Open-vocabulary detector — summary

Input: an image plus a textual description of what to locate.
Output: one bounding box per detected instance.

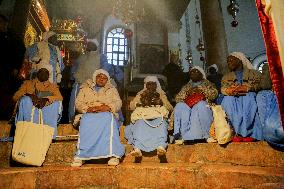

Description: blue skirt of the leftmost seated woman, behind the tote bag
[15,96,62,139]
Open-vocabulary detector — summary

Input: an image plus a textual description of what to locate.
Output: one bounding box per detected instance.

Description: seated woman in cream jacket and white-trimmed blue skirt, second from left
[71,69,125,167]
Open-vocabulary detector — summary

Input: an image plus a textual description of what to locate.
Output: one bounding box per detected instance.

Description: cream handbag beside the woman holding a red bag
[211,105,233,144]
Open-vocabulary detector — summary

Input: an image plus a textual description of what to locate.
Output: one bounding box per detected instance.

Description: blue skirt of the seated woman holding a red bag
[174,100,213,140]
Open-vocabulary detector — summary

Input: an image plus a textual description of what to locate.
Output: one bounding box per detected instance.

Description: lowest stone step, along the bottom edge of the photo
[0,163,284,189]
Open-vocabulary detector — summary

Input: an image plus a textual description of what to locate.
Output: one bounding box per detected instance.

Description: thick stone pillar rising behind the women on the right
[200,0,228,73]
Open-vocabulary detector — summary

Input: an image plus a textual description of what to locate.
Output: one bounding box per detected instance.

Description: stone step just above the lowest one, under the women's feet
[0,140,284,168]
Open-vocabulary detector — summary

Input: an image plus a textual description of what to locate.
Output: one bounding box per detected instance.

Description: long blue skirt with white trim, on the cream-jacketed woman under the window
[75,112,125,160]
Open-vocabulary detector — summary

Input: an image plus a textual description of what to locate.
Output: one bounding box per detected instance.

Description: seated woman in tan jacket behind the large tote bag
[13,68,63,138]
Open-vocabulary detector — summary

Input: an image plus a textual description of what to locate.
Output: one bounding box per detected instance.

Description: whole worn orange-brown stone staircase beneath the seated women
[0,122,284,189]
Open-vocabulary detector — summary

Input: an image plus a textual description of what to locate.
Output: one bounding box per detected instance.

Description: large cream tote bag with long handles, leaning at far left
[12,107,54,166]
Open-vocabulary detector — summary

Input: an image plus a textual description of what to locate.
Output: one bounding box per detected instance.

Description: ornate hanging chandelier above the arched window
[113,0,145,25]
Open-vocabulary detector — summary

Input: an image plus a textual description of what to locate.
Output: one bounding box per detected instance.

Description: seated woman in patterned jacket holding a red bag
[174,66,218,144]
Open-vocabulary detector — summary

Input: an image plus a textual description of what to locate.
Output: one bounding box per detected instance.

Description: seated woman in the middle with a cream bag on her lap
[124,76,173,157]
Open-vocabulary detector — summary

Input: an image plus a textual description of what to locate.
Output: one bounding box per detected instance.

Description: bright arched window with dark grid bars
[106,28,128,66]
